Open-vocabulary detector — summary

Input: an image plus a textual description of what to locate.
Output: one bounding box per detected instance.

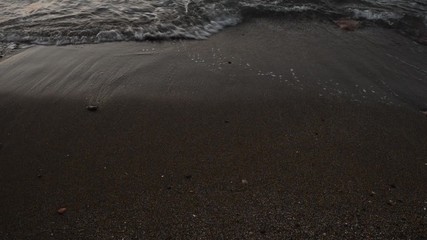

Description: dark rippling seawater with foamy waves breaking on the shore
[0,0,427,45]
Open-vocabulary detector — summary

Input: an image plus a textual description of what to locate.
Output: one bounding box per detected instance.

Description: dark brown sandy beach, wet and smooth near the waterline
[0,18,427,239]
